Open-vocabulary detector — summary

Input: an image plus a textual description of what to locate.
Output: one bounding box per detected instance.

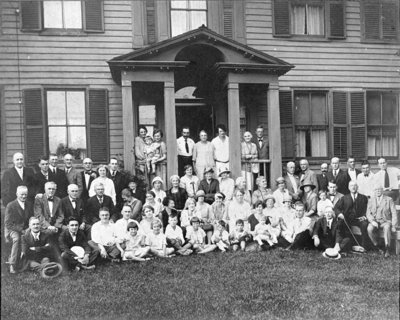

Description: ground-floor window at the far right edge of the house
[367,92,399,157]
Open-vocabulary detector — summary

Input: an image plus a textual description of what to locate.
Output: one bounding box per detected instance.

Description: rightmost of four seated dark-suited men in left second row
[83,182,115,227]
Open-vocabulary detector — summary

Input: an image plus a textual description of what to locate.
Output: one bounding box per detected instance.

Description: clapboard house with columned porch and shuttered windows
[0,0,400,188]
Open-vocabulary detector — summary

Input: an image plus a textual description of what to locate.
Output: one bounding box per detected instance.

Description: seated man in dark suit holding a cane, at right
[334,181,368,248]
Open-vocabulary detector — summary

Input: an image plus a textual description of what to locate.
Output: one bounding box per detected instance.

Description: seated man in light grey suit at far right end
[367,185,397,257]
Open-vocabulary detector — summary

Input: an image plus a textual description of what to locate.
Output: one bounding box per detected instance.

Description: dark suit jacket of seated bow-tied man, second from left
[33,195,64,230]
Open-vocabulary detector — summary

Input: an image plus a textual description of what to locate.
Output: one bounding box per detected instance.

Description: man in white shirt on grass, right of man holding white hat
[89,207,120,262]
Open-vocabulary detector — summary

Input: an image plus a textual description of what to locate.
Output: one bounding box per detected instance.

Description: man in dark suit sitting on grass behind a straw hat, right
[312,207,350,252]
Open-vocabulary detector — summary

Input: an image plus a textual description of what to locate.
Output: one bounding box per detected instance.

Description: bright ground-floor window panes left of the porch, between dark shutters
[46,91,87,159]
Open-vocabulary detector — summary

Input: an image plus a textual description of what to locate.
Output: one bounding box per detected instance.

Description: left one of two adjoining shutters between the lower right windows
[333,92,347,159]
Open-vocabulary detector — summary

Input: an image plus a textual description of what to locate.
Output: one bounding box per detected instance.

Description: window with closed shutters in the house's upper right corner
[361,0,400,42]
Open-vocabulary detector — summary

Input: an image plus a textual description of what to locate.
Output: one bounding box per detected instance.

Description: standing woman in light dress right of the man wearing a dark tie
[193,130,215,178]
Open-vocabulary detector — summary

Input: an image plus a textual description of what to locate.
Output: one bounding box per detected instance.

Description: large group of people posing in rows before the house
[1,132,400,273]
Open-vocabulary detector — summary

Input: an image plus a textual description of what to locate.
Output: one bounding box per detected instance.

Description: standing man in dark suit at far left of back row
[1,152,35,207]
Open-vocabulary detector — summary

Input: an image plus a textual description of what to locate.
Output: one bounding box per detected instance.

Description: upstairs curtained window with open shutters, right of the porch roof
[273,0,346,39]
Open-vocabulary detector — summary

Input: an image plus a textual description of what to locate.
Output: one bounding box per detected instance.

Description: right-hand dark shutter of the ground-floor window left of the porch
[89,89,109,162]
